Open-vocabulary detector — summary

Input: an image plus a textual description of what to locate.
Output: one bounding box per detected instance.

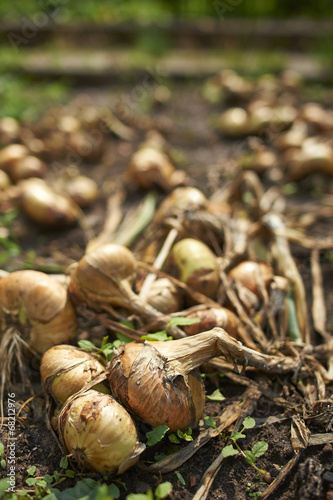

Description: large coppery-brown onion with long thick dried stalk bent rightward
[107,327,299,431]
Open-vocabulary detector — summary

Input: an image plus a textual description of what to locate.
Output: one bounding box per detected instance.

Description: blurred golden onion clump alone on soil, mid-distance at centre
[126,133,188,191]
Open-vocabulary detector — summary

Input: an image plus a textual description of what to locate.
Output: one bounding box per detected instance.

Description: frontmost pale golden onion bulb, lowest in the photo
[58,390,145,474]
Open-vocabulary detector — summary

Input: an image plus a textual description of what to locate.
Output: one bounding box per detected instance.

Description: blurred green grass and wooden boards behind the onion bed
[0,0,333,119]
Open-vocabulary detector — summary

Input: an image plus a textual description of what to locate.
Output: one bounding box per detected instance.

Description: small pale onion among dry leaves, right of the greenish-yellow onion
[228,260,273,295]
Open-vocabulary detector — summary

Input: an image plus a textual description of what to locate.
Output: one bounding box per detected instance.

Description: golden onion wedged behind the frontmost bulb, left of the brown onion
[40,345,108,404]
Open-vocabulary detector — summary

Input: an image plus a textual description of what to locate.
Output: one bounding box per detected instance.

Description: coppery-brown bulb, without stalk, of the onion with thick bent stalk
[107,342,205,431]
